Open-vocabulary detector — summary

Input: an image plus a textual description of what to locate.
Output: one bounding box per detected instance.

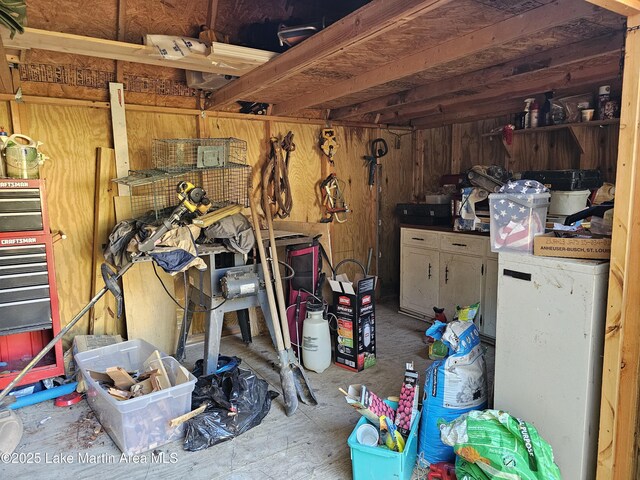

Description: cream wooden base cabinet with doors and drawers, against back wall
[400,228,498,337]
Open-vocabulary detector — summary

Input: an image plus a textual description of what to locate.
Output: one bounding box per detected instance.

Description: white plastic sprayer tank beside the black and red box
[302,301,331,373]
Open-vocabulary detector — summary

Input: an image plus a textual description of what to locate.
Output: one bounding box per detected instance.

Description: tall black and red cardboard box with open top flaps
[329,276,376,372]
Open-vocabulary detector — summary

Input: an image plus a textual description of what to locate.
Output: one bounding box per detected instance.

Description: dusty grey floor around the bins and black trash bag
[0,305,492,480]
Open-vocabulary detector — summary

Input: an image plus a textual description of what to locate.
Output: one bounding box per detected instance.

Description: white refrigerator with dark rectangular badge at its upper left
[494,253,609,480]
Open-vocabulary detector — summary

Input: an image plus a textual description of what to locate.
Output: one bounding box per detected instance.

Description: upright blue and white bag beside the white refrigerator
[418,320,487,466]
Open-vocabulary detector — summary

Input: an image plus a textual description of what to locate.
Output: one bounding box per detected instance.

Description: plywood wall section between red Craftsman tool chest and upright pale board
[22,105,111,335]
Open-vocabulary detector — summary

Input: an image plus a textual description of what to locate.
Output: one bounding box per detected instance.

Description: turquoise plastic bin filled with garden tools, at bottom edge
[347,402,420,480]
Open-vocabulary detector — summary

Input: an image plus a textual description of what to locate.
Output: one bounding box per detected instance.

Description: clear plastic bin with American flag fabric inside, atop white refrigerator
[489,193,551,253]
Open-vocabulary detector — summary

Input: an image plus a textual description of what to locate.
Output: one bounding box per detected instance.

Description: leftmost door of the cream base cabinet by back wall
[400,245,439,317]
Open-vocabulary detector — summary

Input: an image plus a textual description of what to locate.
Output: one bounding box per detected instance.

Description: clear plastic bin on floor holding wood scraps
[75,340,196,455]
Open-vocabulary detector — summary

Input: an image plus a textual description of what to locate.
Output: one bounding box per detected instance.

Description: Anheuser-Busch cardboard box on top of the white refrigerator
[533,232,611,260]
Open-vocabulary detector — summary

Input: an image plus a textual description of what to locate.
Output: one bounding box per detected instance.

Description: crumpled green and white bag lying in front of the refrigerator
[440,410,562,480]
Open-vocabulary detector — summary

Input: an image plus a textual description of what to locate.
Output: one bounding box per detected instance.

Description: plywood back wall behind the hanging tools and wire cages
[0,99,411,337]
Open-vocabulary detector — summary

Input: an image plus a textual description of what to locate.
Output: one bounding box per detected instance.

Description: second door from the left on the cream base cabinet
[439,253,482,320]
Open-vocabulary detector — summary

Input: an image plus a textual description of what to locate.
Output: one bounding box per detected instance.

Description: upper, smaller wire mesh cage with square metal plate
[151,138,247,172]
